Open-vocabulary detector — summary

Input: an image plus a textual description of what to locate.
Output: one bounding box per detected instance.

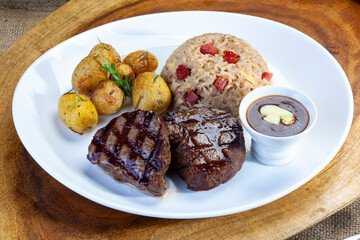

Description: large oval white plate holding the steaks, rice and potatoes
[13,12,353,218]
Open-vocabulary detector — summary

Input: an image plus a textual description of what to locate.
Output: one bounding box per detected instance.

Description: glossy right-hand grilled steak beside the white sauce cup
[165,108,245,191]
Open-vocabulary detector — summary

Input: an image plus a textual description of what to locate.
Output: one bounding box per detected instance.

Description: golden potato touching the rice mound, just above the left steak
[132,72,171,113]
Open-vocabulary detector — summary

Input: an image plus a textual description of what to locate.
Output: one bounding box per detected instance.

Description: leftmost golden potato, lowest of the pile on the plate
[58,93,98,134]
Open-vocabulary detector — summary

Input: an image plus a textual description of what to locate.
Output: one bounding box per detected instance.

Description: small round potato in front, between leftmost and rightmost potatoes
[91,80,126,115]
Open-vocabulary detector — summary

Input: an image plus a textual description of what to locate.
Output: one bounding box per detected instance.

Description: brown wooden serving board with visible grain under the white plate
[0,0,360,239]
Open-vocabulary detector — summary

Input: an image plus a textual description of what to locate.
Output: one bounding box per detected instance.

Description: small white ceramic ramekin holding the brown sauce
[239,86,317,165]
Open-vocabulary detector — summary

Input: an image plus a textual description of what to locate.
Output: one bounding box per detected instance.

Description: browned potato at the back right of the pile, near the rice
[123,50,158,76]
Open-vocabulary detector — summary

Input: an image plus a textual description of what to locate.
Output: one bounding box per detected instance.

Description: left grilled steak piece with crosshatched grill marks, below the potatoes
[87,110,171,196]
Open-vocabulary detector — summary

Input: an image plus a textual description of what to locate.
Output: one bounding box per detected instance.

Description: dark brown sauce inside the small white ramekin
[246,95,309,137]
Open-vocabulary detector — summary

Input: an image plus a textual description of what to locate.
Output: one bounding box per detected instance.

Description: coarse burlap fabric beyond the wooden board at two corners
[0,0,360,240]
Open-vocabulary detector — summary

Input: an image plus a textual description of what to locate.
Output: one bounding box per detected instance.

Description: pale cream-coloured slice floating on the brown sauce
[260,105,295,125]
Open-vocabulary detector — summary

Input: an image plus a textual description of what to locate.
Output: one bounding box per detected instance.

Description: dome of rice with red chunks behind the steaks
[161,33,272,117]
